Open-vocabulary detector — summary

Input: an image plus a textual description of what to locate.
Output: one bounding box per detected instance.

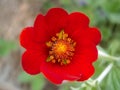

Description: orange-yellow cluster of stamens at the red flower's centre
[46,30,76,65]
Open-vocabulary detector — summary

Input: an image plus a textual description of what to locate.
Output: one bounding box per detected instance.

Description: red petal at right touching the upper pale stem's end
[75,34,98,63]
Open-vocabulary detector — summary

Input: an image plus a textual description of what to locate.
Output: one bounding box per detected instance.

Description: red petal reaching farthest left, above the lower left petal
[20,27,40,49]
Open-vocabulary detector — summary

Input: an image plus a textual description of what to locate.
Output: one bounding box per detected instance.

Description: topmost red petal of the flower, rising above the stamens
[45,8,68,36]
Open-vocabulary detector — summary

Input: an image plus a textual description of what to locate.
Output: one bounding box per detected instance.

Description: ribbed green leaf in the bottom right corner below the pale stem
[101,64,120,90]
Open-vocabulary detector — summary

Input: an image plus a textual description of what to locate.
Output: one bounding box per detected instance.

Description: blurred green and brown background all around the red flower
[0,0,120,90]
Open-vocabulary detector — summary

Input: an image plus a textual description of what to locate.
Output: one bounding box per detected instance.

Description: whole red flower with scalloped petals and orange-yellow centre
[20,8,101,84]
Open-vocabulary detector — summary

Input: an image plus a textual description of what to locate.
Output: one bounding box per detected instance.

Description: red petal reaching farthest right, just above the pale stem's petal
[70,28,101,45]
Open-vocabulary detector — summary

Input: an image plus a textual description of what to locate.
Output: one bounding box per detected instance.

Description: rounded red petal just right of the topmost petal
[65,12,89,34]
